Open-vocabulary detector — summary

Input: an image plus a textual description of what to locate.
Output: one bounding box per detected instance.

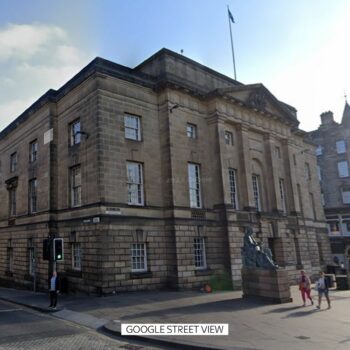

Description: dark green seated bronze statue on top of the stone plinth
[242,227,278,270]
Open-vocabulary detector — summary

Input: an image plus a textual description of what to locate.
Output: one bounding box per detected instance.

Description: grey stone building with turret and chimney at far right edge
[310,102,350,269]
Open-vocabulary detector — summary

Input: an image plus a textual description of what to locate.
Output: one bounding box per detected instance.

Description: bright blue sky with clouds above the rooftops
[0,0,350,131]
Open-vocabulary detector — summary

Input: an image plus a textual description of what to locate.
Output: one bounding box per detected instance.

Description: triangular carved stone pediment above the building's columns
[211,84,299,124]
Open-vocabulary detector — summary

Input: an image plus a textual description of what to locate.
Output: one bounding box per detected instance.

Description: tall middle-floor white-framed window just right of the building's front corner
[126,162,144,205]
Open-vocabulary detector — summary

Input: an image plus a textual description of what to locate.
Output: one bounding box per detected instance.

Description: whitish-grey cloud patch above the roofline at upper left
[0,23,91,130]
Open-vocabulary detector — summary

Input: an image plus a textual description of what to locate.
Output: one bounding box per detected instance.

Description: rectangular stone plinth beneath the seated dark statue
[242,267,293,304]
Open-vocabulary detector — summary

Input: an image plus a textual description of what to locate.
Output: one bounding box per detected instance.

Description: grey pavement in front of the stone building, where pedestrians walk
[0,287,350,350]
